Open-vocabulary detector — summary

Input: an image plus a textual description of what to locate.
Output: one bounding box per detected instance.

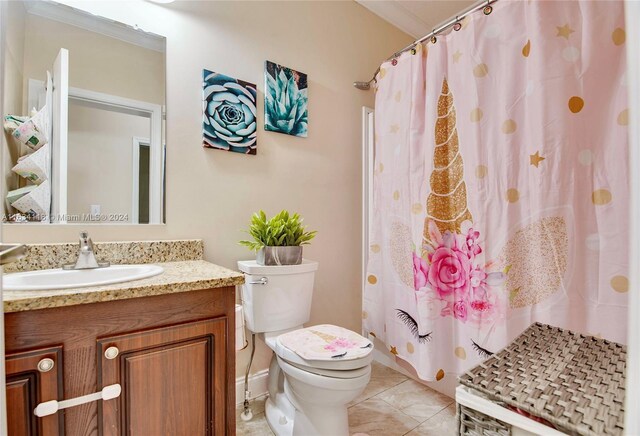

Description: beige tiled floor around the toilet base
[236,362,456,436]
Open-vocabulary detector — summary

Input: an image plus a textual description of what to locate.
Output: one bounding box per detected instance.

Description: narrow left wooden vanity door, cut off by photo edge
[5,347,64,436]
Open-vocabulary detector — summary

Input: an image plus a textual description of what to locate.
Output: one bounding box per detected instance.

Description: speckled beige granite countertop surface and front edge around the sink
[3,260,244,313]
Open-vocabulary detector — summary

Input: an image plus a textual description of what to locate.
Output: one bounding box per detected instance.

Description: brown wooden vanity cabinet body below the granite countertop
[5,287,235,436]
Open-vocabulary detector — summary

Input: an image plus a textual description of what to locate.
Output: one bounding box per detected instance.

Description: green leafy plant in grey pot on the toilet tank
[240,210,317,265]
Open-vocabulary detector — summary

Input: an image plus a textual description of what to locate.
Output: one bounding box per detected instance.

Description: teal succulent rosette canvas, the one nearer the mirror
[202,70,257,154]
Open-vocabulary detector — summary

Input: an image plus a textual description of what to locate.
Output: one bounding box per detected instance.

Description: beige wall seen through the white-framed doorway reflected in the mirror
[67,101,151,221]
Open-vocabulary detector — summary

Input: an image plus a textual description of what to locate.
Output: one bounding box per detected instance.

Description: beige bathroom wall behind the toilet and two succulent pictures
[2,1,411,382]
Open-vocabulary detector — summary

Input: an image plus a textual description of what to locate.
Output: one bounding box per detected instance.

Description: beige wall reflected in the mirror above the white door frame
[23,13,165,105]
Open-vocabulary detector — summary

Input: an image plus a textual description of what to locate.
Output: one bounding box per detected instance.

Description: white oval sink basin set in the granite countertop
[2,265,164,291]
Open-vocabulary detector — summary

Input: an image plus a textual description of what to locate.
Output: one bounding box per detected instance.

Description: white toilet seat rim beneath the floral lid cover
[265,324,373,372]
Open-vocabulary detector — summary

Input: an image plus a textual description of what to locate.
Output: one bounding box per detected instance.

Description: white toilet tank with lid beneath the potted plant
[238,259,318,333]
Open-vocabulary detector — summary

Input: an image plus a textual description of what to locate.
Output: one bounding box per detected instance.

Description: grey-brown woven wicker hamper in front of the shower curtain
[458,323,627,436]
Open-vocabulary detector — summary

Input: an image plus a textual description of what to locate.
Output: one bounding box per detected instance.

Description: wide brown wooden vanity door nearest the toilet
[98,317,229,436]
